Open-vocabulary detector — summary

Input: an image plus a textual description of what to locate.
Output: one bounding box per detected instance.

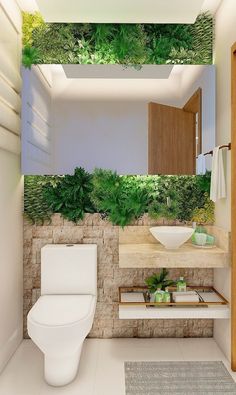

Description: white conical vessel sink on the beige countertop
[150,226,194,250]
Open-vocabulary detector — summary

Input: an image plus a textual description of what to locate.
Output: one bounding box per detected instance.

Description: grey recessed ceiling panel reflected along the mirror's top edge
[63,64,174,79]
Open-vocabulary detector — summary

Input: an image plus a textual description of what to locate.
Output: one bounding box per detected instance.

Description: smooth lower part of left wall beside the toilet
[0,148,23,371]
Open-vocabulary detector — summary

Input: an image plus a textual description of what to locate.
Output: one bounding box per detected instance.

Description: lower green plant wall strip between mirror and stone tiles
[24,168,214,227]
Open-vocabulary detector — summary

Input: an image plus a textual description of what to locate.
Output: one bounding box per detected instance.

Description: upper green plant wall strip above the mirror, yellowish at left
[23,13,214,67]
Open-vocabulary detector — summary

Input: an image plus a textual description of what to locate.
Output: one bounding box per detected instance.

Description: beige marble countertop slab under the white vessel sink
[119,243,230,269]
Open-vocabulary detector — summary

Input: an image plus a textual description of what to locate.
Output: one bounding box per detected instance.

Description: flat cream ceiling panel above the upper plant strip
[37,0,204,23]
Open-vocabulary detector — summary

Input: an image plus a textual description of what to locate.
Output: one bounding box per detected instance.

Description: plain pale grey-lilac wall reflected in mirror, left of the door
[53,99,148,174]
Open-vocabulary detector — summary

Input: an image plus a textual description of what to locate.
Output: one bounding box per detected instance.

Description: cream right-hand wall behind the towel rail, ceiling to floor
[214,0,236,359]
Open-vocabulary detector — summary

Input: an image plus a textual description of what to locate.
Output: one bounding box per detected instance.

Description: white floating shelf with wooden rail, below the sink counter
[119,287,230,319]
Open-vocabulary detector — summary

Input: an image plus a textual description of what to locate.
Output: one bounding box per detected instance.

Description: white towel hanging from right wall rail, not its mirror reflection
[210,147,226,202]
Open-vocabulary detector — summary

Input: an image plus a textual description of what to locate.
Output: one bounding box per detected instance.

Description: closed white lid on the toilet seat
[29,295,96,326]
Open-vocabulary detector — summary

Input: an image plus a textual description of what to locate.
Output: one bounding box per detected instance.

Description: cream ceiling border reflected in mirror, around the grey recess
[45,65,210,105]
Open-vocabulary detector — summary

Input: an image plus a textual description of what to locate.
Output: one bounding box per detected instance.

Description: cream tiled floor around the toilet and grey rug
[0,339,236,395]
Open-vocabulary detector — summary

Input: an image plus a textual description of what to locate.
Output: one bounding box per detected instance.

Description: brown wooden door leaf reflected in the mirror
[148,103,196,175]
